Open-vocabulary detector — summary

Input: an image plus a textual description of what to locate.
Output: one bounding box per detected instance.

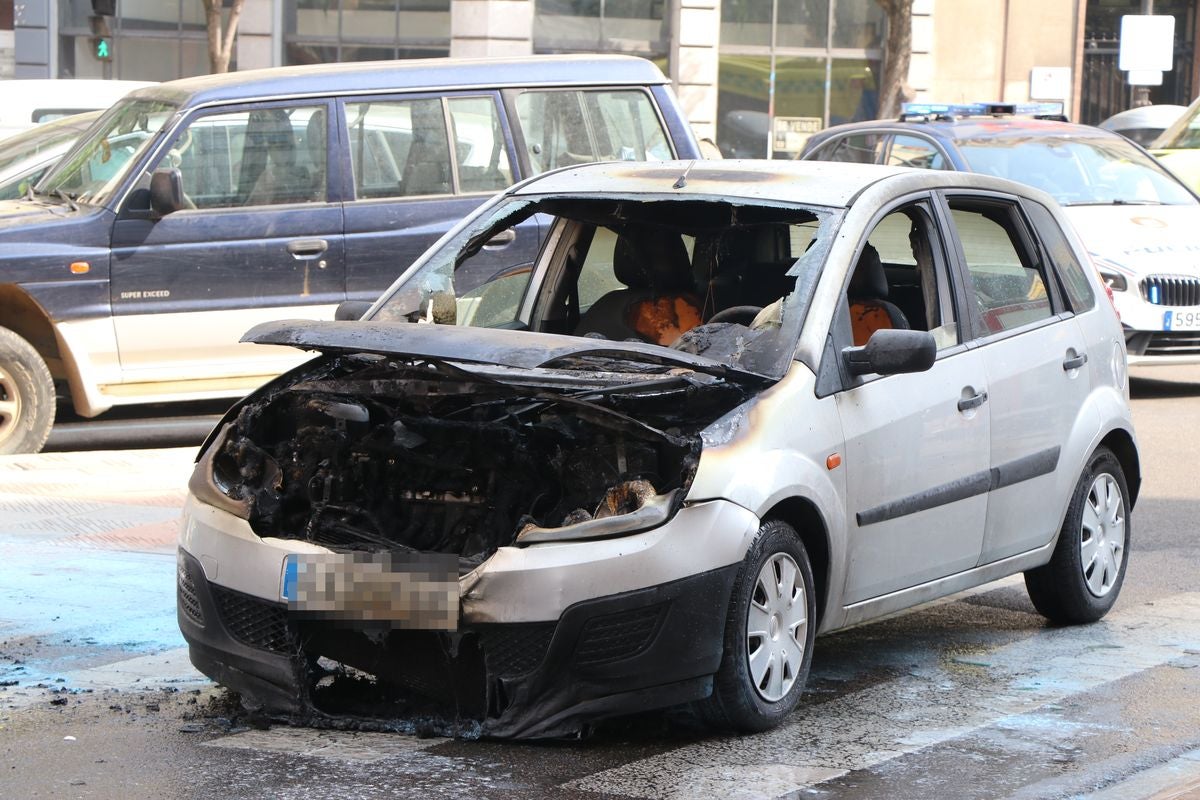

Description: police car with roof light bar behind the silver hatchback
[802,103,1200,365]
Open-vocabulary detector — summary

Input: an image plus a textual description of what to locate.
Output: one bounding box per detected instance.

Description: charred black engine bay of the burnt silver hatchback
[214,355,745,572]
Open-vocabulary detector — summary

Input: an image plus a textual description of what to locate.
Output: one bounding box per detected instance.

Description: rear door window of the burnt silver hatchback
[948,203,1054,336]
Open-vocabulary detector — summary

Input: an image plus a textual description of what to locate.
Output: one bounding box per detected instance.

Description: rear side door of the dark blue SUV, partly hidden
[338,92,540,301]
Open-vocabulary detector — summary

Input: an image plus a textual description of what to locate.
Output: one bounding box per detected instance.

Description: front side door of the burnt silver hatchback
[832,199,991,604]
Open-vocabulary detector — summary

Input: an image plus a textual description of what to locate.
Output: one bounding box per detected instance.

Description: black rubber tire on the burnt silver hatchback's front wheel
[700,519,816,733]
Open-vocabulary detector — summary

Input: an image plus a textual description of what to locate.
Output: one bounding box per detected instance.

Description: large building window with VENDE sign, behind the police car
[716,0,884,158]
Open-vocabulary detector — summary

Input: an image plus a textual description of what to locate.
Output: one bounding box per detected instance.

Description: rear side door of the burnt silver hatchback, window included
[946,192,1091,564]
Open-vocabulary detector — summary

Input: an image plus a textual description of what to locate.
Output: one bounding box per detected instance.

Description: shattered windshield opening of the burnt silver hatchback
[371,196,839,377]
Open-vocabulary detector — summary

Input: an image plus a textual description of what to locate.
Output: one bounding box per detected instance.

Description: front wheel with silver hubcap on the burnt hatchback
[701,519,816,733]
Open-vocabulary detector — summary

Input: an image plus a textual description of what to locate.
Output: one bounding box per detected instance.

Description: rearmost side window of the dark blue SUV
[516,89,672,174]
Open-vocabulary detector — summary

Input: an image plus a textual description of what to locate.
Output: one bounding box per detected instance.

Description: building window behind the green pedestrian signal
[59,0,211,80]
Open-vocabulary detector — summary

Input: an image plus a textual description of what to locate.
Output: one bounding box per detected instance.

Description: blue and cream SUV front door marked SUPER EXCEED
[110,101,344,383]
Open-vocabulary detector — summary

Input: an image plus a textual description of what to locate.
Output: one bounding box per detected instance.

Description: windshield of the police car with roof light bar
[958,136,1196,205]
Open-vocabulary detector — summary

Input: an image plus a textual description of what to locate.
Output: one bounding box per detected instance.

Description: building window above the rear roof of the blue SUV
[533,0,671,71]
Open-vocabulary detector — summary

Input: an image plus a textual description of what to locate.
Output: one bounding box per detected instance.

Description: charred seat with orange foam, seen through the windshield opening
[576,227,702,345]
